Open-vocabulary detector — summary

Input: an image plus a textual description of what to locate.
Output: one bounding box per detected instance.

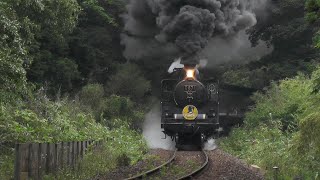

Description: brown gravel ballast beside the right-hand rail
[195,149,264,180]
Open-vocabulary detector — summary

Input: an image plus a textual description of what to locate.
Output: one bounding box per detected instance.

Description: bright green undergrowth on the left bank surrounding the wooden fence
[0,86,147,179]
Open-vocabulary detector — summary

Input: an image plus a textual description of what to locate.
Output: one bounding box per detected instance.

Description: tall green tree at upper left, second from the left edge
[17,0,81,92]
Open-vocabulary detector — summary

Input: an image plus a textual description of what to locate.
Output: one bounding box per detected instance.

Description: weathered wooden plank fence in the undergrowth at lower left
[14,141,101,180]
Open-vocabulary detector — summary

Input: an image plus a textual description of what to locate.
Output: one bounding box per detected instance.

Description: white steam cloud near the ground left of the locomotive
[143,103,175,150]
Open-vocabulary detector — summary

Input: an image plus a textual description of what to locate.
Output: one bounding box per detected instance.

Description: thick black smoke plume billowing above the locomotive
[121,0,267,64]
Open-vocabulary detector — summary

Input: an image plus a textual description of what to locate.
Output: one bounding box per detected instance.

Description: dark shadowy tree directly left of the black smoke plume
[70,0,126,84]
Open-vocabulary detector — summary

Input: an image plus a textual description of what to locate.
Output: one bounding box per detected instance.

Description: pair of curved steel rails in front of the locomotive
[126,150,209,180]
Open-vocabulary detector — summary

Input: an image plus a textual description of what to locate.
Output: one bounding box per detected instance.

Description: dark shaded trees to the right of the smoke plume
[222,0,320,89]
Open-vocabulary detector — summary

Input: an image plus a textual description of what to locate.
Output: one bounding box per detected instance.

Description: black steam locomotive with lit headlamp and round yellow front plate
[161,65,252,149]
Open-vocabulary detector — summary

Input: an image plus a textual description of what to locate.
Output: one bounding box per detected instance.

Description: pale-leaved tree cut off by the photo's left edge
[0,2,26,102]
